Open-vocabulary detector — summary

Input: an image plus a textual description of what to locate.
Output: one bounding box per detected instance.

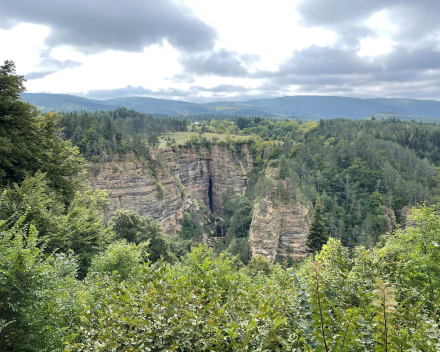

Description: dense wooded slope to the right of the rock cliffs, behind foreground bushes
[237,118,440,247]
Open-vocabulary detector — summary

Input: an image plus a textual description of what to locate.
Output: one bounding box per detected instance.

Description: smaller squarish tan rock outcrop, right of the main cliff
[249,172,310,262]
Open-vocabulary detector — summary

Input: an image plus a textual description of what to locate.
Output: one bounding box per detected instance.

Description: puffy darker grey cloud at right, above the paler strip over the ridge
[252,46,440,84]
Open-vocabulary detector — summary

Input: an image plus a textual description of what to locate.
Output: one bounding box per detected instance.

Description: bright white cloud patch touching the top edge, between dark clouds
[182,0,335,70]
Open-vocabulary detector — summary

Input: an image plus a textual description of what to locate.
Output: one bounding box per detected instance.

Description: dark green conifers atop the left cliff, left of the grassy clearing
[57,108,189,162]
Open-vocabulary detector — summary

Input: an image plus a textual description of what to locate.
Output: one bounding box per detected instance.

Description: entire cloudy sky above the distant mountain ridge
[0,0,440,102]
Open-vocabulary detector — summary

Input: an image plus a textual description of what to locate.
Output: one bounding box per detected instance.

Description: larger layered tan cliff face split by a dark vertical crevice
[90,146,252,233]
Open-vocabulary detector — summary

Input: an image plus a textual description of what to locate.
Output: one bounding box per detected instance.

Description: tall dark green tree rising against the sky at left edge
[0,61,84,203]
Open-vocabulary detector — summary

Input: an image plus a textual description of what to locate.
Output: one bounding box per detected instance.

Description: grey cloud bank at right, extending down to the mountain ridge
[253,43,440,99]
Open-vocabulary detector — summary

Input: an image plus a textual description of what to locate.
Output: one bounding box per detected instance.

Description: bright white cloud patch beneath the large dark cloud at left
[27,44,180,93]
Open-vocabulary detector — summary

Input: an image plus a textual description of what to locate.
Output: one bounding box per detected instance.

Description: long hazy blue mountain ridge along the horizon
[21,93,440,120]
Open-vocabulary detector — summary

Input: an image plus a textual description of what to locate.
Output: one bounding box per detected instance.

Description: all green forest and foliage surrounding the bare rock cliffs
[0,61,440,352]
